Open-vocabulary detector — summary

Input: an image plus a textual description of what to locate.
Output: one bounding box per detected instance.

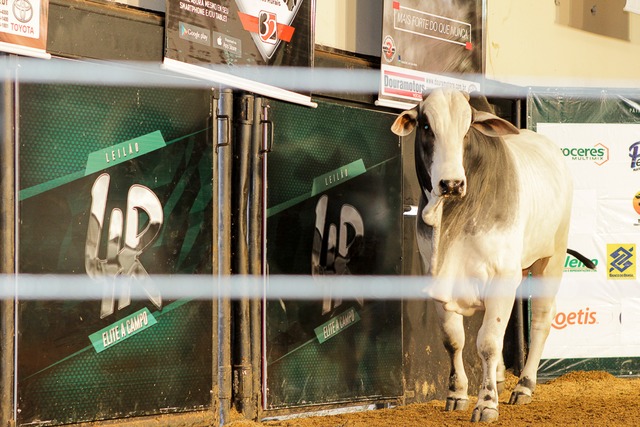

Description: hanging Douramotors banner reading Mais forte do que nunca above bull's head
[378,0,483,108]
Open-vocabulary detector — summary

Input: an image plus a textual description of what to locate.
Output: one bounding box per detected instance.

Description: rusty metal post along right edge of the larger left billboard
[214,89,233,424]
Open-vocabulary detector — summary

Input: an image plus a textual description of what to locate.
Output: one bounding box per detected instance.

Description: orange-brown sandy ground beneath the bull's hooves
[228,371,640,427]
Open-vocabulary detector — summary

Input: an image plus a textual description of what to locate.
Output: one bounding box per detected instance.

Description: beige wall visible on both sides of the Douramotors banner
[316,0,640,87]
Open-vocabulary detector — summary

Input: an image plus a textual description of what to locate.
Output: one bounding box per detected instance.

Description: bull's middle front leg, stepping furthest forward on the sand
[471,287,515,422]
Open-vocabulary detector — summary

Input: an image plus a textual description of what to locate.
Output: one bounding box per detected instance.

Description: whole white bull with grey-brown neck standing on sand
[392,89,588,421]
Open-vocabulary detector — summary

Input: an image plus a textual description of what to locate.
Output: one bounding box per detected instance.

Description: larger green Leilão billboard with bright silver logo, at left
[16,84,213,425]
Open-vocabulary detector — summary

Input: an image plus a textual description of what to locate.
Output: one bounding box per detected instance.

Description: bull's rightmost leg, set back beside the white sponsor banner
[509,256,564,405]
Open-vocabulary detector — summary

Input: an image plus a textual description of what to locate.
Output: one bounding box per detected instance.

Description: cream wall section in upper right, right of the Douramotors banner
[486,0,640,87]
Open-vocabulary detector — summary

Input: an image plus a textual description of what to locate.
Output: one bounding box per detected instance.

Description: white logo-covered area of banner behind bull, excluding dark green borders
[537,123,640,359]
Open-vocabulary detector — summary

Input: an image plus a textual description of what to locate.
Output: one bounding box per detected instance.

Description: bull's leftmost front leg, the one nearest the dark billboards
[436,303,469,411]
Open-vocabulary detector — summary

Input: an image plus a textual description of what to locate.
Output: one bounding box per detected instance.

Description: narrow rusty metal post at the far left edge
[0,56,17,426]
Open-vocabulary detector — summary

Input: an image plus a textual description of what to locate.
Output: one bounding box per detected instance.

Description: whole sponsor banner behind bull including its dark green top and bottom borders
[529,90,640,376]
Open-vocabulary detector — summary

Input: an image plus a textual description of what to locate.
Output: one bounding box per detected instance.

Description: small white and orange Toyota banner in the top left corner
[0,0,51,58]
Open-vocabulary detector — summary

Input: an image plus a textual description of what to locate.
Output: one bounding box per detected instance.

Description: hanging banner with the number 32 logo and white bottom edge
[164,0,315,106]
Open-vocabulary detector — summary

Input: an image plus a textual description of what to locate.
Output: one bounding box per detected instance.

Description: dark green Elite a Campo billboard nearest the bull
[265,99,403,409]
